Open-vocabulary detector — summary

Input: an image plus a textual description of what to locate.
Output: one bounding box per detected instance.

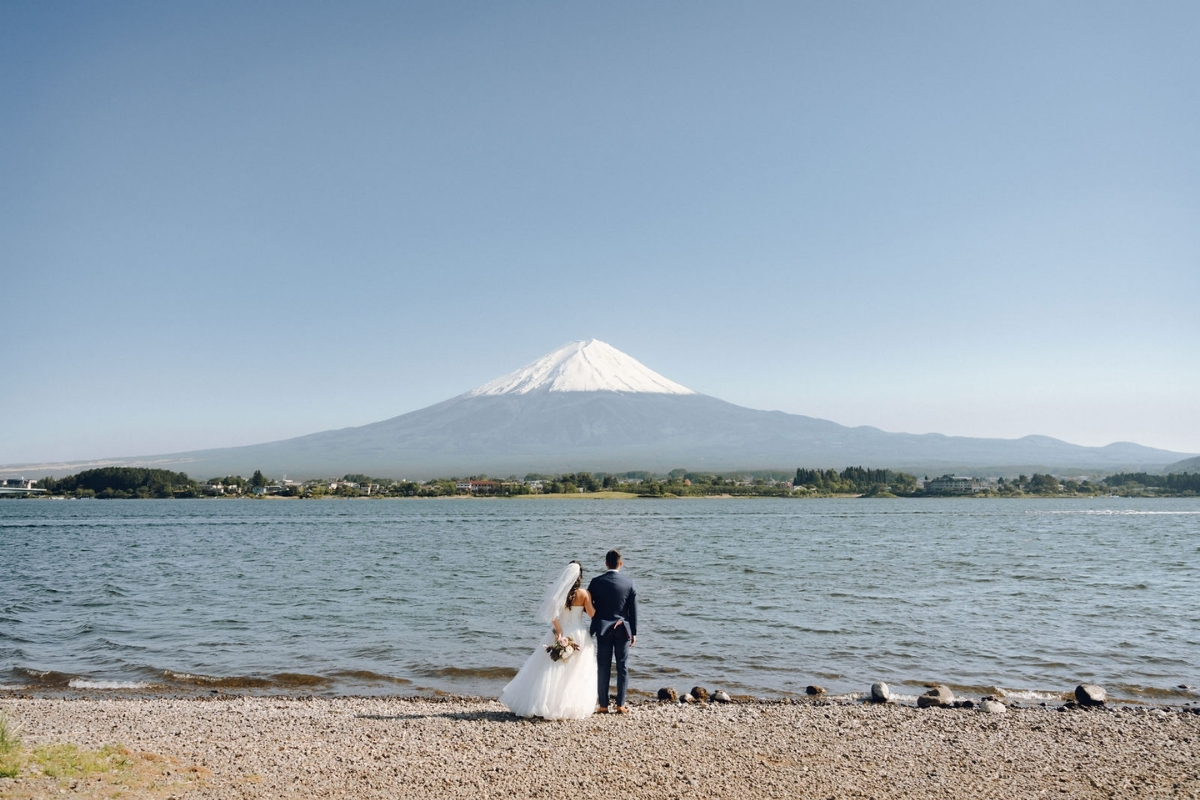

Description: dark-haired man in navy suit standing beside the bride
[588,551,637,714]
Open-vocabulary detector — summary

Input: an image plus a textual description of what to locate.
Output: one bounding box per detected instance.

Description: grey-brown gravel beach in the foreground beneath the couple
[0,696,1200,799]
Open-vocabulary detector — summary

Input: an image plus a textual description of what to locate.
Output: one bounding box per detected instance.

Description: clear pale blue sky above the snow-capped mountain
[0,0,1200,463]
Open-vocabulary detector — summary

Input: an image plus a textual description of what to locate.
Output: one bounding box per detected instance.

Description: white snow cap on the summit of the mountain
[464,339,696,397]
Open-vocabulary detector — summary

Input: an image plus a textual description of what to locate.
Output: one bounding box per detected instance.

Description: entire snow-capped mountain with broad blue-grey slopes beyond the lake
[2,339,1186,479]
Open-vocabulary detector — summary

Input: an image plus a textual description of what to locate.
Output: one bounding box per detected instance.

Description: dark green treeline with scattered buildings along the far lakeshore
[5,467,1200,499]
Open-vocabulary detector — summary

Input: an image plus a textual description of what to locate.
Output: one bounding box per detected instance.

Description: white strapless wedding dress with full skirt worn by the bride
[500,606,596,720]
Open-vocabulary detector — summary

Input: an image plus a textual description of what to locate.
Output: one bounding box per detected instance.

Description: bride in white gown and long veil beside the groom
[500,561,596,720]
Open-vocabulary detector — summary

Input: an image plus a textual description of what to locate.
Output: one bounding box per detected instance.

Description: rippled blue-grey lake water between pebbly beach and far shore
[0,498,1200,702]
